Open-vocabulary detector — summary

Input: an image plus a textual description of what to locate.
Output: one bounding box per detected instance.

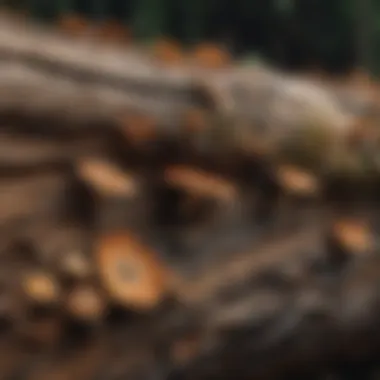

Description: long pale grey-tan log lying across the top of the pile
[0,15,376,151]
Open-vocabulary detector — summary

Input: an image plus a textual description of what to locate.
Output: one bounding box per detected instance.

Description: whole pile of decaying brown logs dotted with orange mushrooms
[0,11,380,380]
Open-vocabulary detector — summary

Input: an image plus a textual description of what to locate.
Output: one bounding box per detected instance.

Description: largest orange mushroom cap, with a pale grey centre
[96,233,167,310]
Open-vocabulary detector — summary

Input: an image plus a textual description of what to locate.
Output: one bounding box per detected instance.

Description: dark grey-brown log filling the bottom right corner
[166,258,379,379]
